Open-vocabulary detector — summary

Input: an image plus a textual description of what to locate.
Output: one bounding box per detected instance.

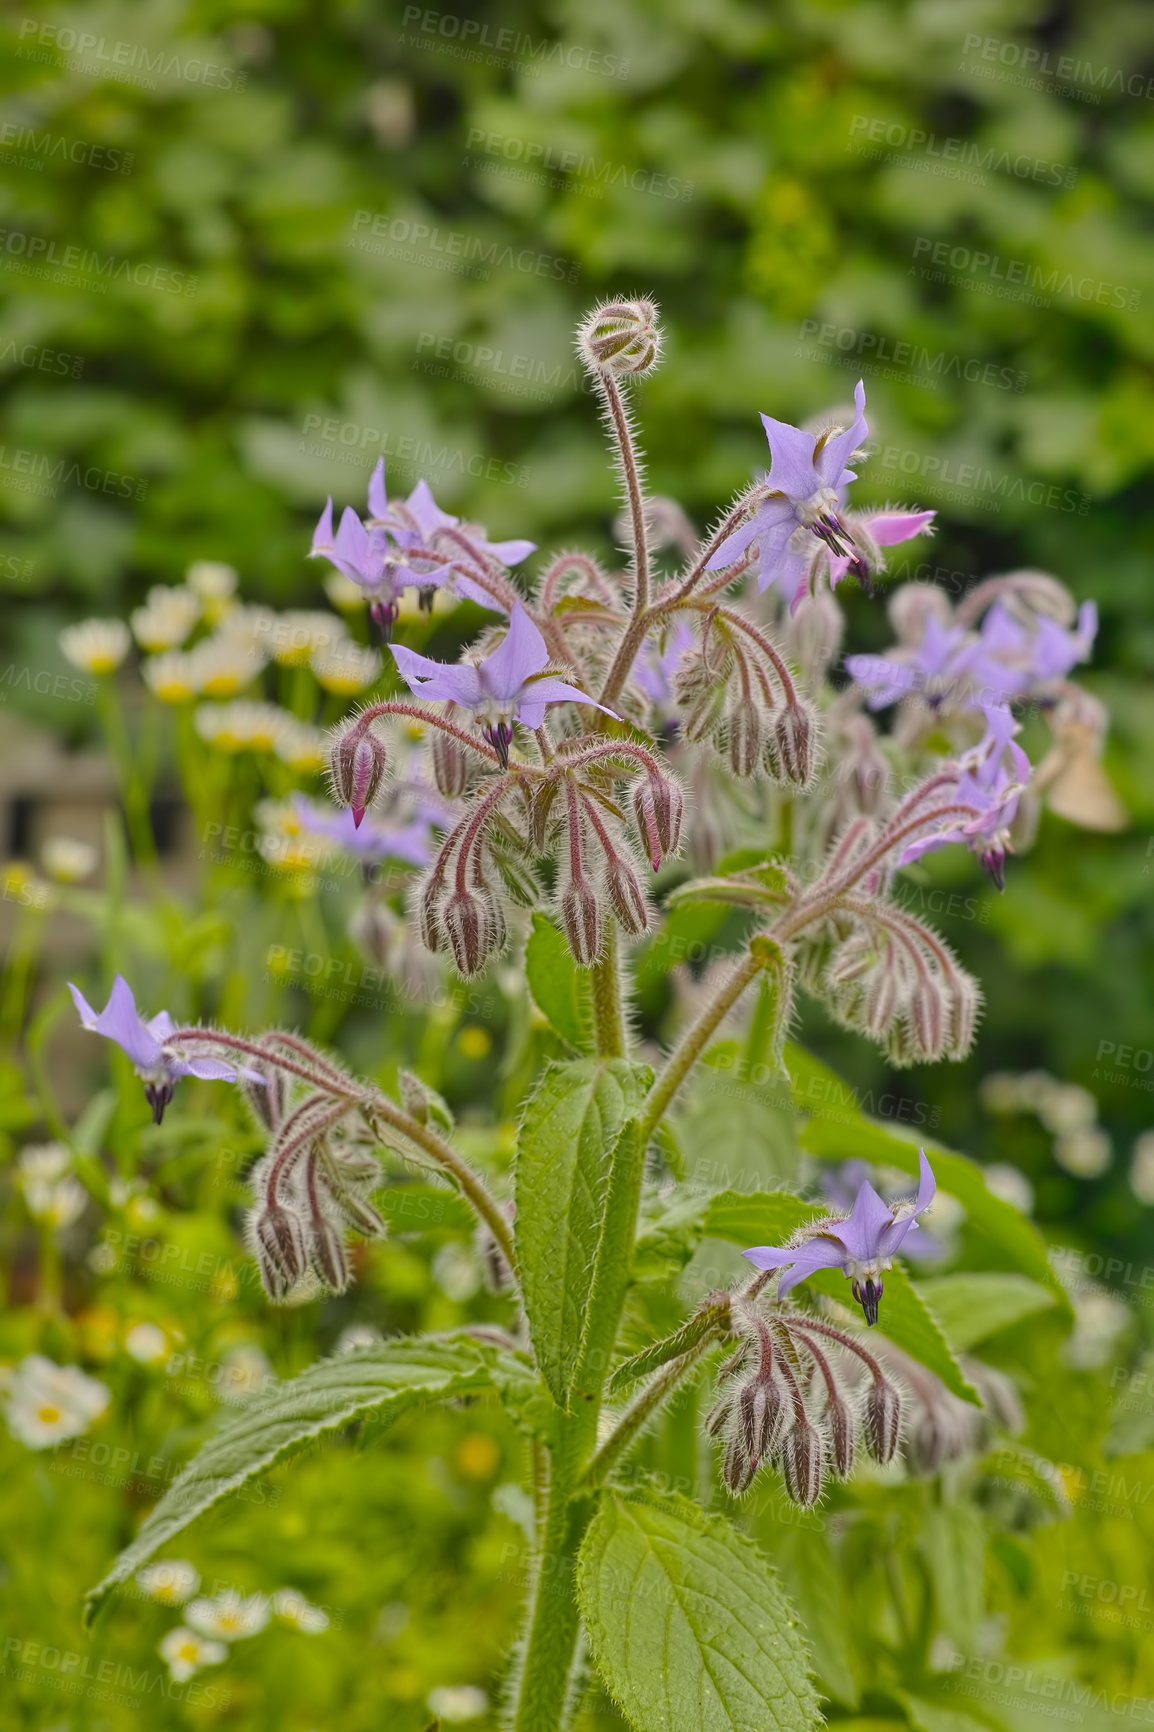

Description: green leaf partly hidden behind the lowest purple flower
[705,1192,979,1403]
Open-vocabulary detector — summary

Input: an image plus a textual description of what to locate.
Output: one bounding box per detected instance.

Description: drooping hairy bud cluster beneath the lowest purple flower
[705,1304,903,1509]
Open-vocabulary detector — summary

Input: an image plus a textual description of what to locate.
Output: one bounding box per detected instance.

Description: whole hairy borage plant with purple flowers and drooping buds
[76,300,1102,1732]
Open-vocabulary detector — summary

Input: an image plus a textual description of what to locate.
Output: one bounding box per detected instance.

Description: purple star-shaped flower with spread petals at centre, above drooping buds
[390,601,615,766]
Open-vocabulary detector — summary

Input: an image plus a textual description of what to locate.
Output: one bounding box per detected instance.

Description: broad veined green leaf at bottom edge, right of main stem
[577,1493,821,1732]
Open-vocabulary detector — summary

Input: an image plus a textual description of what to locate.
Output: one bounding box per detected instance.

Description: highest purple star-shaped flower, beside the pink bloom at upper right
[707,379,873,610]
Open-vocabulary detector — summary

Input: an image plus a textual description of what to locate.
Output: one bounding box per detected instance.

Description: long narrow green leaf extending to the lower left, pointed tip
[85,1337,513,1621]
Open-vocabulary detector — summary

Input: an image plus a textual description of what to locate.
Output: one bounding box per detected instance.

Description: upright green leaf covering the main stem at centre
[515,1058,643,1406]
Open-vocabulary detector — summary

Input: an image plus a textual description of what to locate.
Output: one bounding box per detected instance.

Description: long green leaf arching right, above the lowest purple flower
[785,1044,1069,1315]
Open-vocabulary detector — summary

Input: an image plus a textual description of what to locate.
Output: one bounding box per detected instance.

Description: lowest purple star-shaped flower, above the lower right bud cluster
[742,1148,937,1327]
